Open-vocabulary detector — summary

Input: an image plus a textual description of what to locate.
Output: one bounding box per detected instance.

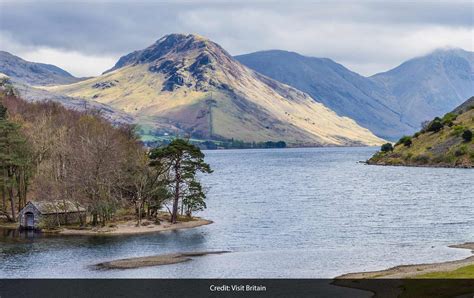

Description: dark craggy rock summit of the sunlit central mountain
[104,34,242,92]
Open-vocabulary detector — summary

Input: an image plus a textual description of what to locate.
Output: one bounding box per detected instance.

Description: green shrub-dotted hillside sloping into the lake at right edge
[367,97,474,168]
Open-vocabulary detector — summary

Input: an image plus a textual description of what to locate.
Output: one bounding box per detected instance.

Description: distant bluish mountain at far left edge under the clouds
[0,51,80,85]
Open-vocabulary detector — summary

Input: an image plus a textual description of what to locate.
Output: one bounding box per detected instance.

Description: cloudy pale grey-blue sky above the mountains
[0,0,474,76]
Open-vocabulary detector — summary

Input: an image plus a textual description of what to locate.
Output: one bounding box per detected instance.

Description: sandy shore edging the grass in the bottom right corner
[336,242,474,279]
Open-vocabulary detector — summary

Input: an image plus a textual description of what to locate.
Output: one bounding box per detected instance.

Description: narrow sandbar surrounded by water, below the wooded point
[95,251,229,269]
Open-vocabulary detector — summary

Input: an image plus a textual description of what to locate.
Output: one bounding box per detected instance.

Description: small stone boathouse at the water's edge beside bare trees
[18,200,86,229]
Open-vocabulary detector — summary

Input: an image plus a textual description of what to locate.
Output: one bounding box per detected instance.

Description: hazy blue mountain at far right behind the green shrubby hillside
[370,49,474,127]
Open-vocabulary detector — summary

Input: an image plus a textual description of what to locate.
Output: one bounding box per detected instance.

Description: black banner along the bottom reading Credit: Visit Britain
[0,279,474,298]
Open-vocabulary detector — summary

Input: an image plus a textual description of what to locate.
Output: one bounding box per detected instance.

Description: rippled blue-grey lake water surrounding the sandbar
[0,148,474,278]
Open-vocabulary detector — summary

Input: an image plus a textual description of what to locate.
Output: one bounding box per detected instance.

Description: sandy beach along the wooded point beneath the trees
[57,217,212,236]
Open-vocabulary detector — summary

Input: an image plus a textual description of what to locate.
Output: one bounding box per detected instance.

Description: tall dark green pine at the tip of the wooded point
[150,139,212,223]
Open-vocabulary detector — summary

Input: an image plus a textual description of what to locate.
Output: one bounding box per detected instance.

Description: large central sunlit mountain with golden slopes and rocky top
[44,34,382,146]
